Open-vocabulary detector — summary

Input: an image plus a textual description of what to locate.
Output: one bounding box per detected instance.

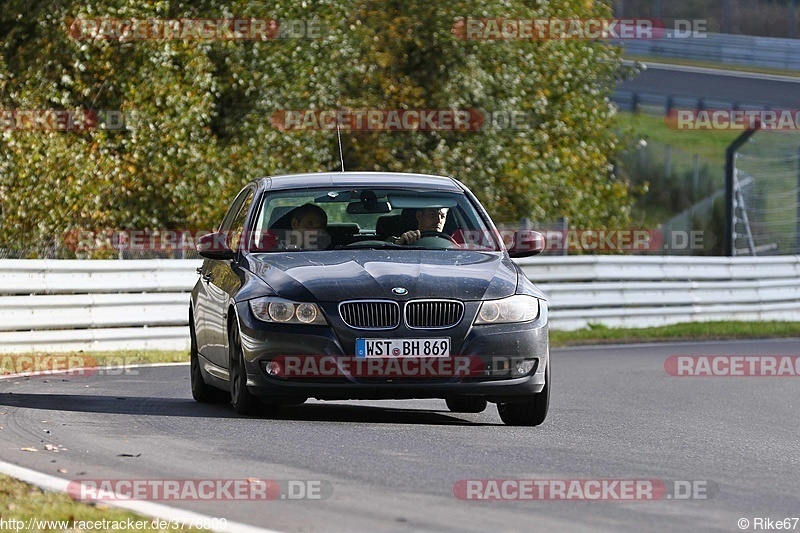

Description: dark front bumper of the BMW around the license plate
[237,302,550,403]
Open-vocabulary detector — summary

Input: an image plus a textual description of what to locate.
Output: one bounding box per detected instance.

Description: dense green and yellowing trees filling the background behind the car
[0,0,630,253]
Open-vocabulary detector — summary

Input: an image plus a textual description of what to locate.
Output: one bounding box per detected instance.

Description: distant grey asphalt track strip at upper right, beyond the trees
[618,62,800,109]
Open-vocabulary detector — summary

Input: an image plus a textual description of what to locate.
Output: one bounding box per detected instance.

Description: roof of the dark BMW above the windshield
[250,172,462,192]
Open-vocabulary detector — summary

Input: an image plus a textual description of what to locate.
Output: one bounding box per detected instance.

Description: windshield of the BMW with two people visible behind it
[249,188,502,253]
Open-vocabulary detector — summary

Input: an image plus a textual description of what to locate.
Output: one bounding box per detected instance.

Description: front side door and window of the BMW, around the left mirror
[203,187,255,368]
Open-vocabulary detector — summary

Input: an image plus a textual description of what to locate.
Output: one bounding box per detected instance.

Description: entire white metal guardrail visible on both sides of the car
[0,256,800,353]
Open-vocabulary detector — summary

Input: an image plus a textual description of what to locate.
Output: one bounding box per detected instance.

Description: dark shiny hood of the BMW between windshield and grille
[250,250,517,302]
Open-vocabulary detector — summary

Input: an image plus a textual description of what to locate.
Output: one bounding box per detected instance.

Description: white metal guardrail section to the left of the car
[0,259,202,353]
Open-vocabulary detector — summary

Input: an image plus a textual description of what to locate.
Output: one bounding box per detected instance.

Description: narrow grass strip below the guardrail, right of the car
[550,321,800,347]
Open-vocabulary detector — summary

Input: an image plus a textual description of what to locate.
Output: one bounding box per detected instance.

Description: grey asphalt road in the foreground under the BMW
[0,339,800,532]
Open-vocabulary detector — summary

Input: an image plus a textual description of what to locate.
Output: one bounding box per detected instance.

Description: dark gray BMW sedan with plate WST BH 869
[189,172,550,426]
